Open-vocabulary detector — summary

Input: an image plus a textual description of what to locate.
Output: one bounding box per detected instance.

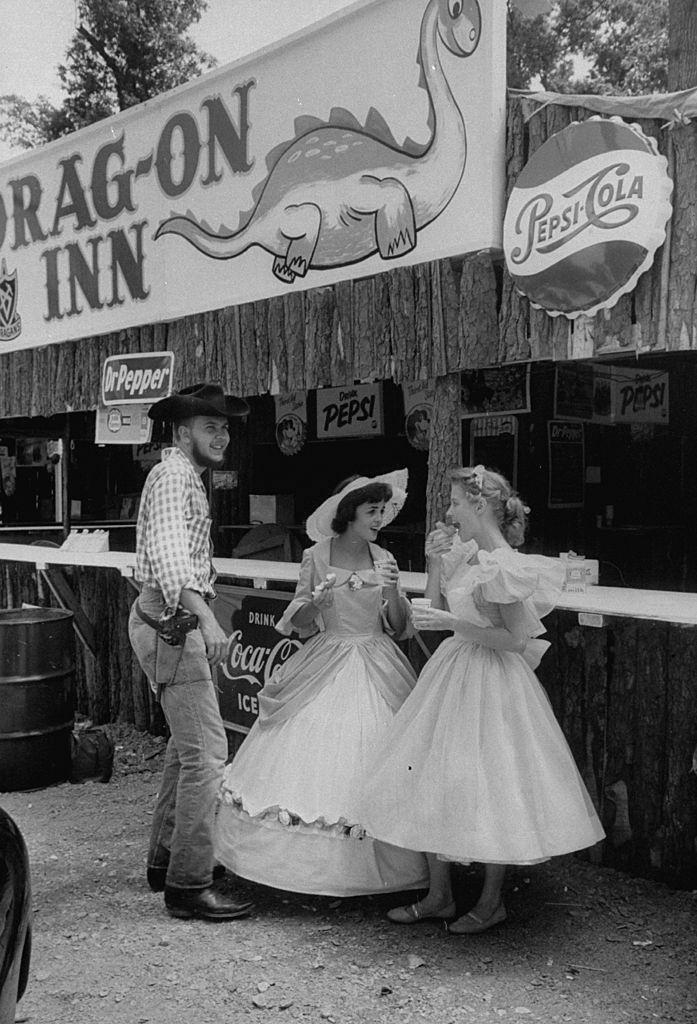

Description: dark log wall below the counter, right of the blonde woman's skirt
[538,610,697,889]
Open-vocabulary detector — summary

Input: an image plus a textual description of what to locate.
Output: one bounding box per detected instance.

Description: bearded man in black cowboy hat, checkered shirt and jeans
[129,384,252,921]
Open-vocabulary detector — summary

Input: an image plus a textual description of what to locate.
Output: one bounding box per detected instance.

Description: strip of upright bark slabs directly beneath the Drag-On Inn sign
[0,253,497,420]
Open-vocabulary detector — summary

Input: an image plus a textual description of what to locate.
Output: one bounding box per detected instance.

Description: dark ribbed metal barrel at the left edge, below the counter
[0,608,75,793]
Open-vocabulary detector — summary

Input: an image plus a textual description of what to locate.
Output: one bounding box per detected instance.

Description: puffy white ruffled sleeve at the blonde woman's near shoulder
[475,548,566,637]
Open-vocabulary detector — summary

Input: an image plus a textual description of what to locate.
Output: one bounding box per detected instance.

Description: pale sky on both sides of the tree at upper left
[0,0,352,161]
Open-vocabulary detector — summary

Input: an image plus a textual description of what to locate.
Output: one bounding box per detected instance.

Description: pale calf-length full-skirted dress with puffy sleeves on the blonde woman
[362,543,605,864]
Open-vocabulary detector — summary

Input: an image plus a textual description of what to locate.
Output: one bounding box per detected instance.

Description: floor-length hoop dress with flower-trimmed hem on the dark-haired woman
[216,540,428,896]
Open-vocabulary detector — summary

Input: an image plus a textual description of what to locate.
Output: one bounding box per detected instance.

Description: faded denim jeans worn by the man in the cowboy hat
[128,588,227,889]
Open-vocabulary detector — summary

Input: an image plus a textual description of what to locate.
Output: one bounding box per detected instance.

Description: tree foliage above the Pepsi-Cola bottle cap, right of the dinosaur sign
[508,0,670,95]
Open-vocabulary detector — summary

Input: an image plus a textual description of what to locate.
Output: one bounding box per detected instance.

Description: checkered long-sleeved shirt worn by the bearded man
[135,447,215,611]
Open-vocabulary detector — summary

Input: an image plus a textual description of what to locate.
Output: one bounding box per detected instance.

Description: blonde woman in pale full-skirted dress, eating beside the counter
[362,466,604,934]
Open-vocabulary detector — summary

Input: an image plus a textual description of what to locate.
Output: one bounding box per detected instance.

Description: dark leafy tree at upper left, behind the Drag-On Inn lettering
[0,0,215,148]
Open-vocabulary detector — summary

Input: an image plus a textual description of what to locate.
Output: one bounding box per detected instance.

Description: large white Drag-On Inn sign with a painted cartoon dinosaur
[0,0,506,352]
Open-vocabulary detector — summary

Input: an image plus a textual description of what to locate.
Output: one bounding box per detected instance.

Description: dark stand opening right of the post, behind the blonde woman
[463,352,697,591]
